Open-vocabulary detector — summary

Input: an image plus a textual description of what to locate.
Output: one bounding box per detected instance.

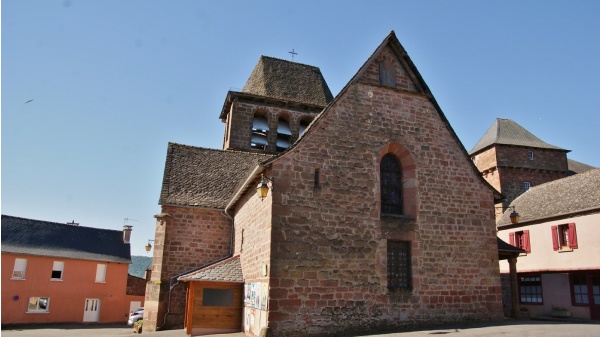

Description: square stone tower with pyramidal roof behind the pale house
[469,118,569,218]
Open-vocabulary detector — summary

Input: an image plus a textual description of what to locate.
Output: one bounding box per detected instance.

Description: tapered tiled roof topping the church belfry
[242,56,333,106]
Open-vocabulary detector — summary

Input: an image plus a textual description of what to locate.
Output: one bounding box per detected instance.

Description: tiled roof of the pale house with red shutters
[498,169,600,226]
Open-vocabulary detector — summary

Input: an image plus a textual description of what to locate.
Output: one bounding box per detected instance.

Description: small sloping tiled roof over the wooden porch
[179,255,244,283]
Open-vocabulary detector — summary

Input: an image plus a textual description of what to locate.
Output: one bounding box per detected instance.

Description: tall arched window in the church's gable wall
[379,153,403,214]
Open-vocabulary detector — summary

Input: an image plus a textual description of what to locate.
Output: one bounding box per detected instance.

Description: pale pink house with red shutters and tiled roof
[498,169,600,320]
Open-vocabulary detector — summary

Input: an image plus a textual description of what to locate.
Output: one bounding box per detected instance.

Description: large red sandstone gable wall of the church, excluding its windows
[258,44,502,336]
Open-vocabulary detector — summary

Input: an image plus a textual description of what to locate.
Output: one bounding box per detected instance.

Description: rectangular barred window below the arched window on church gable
[387,240,411,289]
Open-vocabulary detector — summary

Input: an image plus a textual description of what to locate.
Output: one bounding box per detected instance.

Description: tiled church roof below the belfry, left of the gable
[159,143,271,209]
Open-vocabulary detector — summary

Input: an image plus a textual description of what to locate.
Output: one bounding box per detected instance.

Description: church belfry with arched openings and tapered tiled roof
[220,56,333,154]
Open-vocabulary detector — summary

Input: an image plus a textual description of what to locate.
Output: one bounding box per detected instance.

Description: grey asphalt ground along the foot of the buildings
[1,321,600,337]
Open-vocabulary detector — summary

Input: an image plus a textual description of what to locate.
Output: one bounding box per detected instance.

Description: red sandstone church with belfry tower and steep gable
[144,31,503,336]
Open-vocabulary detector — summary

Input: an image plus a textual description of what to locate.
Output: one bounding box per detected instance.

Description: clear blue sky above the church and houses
[1,0,600,256]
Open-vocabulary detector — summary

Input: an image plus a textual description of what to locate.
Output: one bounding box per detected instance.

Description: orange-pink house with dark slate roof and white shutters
[2,215,144,325]
